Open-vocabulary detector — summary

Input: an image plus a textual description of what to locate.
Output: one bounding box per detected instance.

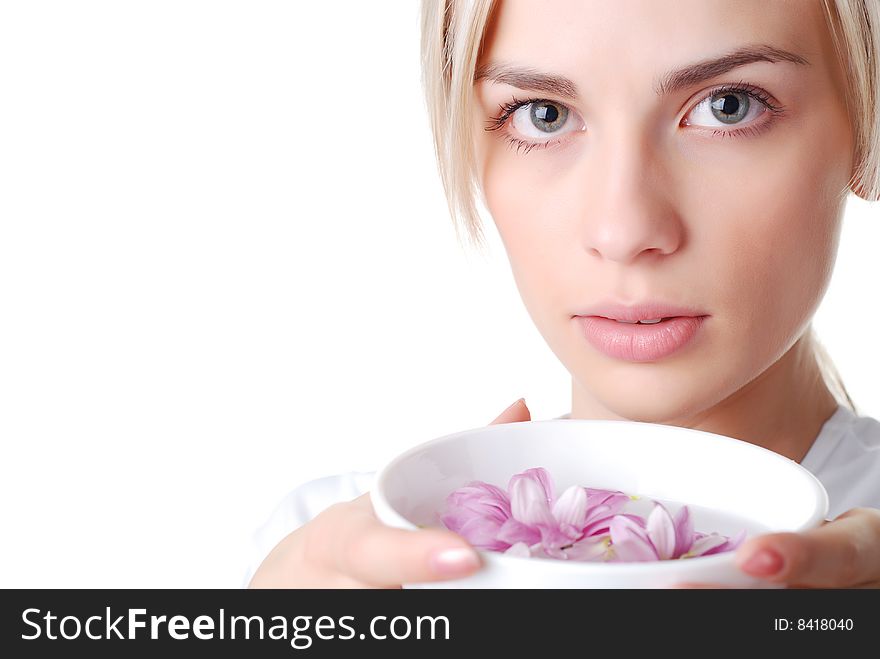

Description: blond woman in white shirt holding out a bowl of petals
[250,0,880,587]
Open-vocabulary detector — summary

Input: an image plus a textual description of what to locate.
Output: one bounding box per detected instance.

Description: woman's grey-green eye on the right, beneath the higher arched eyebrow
[683,83,782,135]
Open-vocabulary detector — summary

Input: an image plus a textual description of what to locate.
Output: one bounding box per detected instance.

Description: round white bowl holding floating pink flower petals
[371,419,828,588]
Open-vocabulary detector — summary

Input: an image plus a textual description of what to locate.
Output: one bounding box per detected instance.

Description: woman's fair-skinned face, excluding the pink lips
[473,0,853,422]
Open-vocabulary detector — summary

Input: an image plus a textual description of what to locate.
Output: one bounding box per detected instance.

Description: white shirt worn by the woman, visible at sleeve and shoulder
[244,405,880,586]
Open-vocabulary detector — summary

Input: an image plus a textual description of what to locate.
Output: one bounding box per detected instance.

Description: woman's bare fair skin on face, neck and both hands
[250,0,880,588]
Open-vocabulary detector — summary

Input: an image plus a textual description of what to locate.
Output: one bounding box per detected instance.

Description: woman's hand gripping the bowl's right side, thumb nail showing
[676,508,880,588]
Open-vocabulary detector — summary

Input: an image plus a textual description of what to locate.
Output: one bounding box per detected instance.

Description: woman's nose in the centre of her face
[583,133,685,263]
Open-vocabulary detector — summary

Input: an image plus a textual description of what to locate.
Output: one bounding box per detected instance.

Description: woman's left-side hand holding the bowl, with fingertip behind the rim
[249,399,531,588]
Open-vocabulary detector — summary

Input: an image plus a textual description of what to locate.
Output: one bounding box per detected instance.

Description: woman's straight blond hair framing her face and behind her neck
[421,0,880,412]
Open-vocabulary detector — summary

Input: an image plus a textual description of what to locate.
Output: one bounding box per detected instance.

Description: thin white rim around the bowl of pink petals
[369,419,829,574]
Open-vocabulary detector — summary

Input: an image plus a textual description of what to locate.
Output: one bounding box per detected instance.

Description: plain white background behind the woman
[0,0,880,587]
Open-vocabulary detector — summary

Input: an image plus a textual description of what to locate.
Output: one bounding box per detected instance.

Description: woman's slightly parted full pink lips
[575,314,708,362]
